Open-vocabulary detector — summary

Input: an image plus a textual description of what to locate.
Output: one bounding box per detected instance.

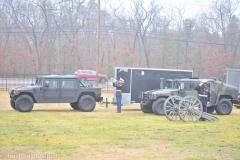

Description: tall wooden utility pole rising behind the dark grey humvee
[96,0,100,87]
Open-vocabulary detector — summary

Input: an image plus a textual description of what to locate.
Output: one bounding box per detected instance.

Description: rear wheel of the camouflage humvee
[216,98,232,115]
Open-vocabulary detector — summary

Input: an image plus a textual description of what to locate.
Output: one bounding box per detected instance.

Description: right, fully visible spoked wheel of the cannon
[178,96,203,122]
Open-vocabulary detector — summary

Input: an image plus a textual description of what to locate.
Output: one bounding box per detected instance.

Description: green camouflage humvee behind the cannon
[139,78,238,115]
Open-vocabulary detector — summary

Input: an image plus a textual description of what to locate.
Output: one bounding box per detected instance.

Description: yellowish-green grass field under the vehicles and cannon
[0,91,240,160]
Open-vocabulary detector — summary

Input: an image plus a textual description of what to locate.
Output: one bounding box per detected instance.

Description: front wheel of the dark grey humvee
[15,95,33,112]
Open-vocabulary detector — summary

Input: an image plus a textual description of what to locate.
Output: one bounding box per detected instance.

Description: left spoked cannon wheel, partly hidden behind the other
[164,96,182,121]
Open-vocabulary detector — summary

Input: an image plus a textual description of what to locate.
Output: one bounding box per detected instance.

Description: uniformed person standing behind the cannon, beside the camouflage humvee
[195,83,210,121]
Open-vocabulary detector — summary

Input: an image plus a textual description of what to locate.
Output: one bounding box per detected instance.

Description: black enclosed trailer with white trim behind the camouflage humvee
[114,67,193,104]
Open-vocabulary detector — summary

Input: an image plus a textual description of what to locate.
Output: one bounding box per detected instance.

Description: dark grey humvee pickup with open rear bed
[9,75,103,112]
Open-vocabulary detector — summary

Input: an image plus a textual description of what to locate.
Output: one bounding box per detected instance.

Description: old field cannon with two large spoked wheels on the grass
[164,95,218,122]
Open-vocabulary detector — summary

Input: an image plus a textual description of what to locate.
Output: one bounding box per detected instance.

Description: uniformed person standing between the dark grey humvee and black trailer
[113,78,124,113]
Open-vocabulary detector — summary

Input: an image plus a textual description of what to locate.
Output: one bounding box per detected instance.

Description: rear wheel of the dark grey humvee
[78,95,96,112]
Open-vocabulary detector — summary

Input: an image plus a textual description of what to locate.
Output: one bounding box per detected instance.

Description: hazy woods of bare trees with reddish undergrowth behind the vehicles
[0,0,240,78]
